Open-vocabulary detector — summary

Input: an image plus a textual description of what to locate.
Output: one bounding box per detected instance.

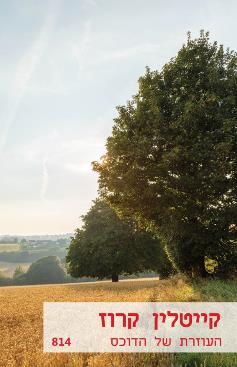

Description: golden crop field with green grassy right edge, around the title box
[0,278,237,367]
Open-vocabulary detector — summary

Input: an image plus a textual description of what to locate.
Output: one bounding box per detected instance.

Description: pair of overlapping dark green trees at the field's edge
[67,31,237,279]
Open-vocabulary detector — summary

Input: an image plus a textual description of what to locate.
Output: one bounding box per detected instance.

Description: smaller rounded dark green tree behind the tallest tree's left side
[66,199,172,281]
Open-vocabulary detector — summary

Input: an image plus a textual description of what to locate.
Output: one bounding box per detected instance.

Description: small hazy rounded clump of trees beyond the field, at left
[20,256,66,284]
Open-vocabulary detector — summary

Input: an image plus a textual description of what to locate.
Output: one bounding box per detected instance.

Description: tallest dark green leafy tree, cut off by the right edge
[94,31,237,275]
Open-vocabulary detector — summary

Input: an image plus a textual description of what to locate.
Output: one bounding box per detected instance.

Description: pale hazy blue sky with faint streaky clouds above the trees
[0,0,237,235]
